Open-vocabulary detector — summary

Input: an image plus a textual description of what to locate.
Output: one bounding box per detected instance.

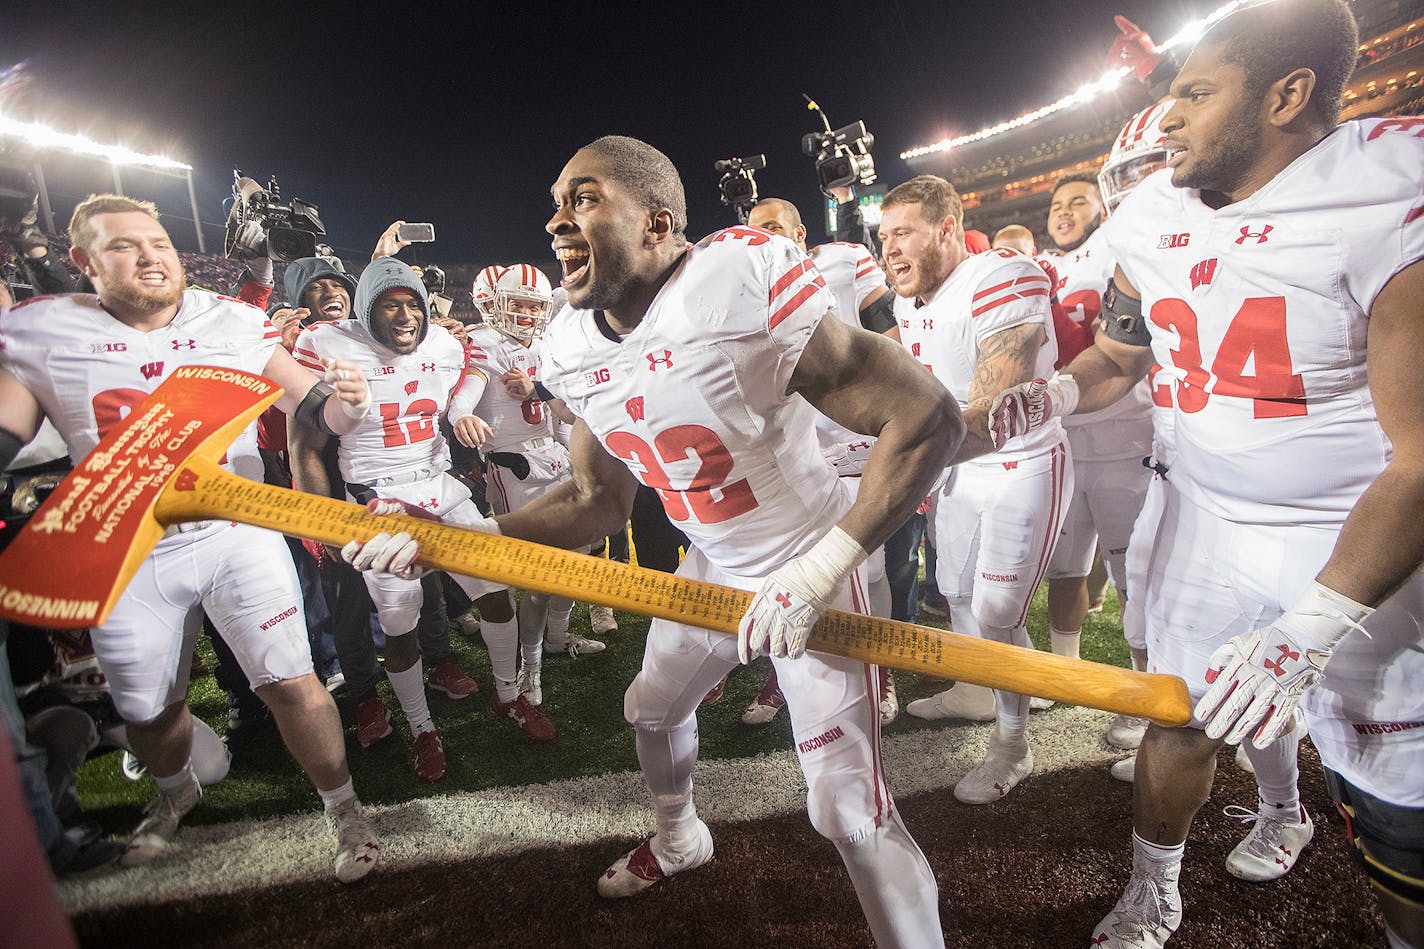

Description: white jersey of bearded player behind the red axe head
[0,289,281,482]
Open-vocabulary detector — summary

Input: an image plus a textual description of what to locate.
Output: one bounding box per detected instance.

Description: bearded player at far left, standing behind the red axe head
[0,195,380,882]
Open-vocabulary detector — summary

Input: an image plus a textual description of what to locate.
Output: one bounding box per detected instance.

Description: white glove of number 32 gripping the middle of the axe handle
[736,527,869,664]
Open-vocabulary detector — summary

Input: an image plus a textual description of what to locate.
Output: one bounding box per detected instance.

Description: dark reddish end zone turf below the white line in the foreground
[74,741,1384,949]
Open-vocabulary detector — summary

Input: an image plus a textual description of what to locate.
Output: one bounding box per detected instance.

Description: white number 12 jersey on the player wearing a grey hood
[293,319,464,484]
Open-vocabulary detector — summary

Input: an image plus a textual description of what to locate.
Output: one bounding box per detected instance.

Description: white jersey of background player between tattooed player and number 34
[1052,225,1152,462]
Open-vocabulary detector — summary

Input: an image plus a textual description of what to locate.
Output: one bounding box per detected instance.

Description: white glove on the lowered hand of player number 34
[1192,583,1374,748]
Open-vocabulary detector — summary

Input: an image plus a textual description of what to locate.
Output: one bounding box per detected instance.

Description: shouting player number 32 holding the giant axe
[350,135,963,946]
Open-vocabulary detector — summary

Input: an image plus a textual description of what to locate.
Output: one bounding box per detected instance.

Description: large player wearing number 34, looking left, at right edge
[995,0,1424,946]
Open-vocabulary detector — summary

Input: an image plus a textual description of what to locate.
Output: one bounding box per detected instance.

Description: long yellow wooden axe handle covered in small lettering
[154,457,1192,725]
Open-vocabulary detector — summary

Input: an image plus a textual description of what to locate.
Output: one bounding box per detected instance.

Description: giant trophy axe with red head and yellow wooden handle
[0,366,1190,725]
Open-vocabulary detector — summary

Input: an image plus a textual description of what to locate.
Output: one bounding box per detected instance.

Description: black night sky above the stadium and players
[0,0,1190,265]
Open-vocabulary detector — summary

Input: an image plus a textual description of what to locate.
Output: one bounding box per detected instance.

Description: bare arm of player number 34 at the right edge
[1317,261,1424,606]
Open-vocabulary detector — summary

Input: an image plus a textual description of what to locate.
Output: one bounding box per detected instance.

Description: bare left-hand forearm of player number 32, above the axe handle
[494,420,638,549]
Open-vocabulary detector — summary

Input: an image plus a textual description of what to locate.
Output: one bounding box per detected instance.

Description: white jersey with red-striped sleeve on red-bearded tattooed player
[894,249,1064,465]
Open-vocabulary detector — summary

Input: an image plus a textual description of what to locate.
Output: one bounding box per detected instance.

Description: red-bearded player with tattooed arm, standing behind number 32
[880,175,1072,804]
